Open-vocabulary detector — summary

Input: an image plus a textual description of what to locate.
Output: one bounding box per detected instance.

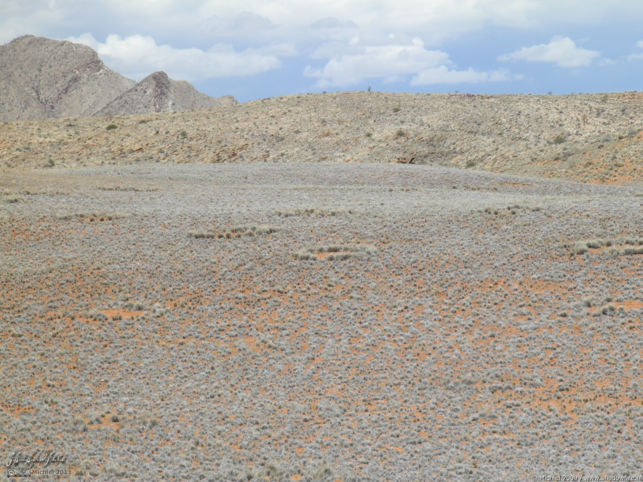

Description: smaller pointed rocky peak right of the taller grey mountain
[96,72,236,116]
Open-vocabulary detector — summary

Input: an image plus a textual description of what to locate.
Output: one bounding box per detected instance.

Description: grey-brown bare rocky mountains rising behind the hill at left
[0,35,237,122]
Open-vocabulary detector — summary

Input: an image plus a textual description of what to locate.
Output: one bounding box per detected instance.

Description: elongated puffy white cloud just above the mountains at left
[67,33,286,82]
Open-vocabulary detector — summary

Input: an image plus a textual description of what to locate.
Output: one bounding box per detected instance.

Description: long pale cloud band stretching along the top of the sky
[7,0,643,46]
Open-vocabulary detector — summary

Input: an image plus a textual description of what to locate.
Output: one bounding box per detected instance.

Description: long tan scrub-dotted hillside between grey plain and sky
[0,92,643,183]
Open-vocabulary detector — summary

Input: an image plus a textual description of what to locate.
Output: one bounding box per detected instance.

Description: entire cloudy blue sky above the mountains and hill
[0,0,643,102]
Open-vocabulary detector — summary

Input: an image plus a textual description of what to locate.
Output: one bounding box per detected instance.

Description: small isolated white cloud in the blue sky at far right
[498,36,600,67]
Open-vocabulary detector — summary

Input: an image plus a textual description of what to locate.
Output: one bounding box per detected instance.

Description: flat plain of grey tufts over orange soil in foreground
[0,163,643,481]
